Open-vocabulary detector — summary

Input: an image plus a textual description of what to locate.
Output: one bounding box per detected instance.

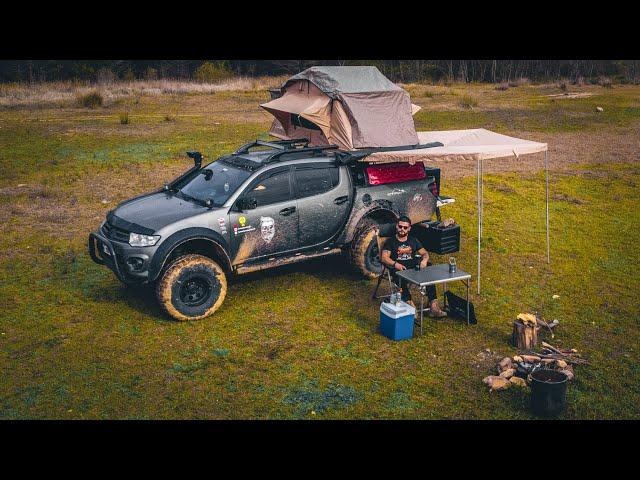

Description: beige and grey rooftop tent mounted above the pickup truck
[261,66,419,150]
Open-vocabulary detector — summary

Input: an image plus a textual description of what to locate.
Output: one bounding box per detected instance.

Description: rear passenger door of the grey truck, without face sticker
[293,163,352,248]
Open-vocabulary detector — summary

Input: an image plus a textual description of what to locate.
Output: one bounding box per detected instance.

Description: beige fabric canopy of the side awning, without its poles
[362,128,547,164]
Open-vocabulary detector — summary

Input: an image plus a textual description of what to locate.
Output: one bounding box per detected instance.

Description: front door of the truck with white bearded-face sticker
[229,166,299,265]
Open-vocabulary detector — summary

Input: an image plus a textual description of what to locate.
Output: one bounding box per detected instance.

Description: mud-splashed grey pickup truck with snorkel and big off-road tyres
[89,140,450,320]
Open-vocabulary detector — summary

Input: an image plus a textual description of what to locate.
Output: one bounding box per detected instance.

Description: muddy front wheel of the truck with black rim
[156,254,227,321]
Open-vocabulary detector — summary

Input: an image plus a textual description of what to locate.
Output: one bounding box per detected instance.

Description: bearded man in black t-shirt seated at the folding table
[380,215,447,317]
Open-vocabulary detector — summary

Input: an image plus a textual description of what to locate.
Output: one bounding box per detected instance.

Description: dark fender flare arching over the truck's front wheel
[149,227,231,281]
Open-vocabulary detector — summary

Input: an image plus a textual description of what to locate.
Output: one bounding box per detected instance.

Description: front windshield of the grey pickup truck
[176,162,251,207]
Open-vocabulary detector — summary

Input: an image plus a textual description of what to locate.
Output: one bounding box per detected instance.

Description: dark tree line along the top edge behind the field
[0,60,640,83]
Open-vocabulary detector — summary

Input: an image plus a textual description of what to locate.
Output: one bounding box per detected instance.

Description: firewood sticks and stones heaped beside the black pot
[482,342,588,391]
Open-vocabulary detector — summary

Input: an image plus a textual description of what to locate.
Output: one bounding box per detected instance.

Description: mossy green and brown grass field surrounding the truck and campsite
[0,80,640,419]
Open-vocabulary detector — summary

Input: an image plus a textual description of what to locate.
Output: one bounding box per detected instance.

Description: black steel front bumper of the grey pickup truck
[89,231,150,285]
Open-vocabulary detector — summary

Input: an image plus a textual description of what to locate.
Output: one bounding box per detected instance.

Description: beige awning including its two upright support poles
[363,128,551,293]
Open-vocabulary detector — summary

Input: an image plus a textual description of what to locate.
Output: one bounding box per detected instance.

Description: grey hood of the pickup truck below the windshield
[109,192,207,233]
